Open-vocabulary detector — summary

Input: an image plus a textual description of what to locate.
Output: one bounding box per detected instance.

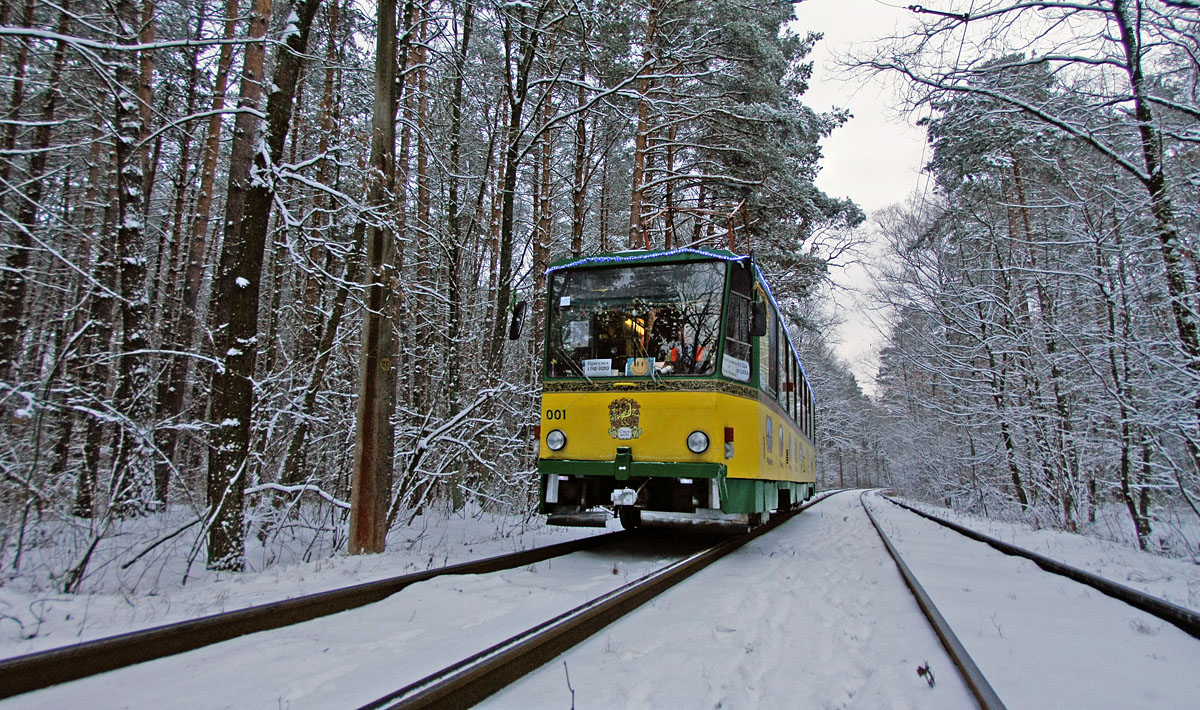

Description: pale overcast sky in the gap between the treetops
[794,0,928,391]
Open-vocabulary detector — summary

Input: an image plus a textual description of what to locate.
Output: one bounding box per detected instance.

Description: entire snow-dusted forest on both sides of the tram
[0,0,1200,592]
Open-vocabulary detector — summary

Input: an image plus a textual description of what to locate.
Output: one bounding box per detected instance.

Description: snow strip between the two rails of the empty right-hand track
[869,495,1200,709]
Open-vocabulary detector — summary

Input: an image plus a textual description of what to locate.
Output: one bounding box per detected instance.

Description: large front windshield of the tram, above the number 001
[546,261,725,379]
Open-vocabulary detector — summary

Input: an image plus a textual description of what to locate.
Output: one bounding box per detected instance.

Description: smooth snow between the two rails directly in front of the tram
[4,534,677,710]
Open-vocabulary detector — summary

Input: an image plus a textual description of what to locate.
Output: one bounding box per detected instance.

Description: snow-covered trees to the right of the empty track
[852,0,1200,558]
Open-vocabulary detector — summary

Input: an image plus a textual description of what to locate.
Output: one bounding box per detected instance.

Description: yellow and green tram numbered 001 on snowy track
[538,248,816,528]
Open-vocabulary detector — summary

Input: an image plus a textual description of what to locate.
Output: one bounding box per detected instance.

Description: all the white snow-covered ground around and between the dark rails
[0,493,1200,709]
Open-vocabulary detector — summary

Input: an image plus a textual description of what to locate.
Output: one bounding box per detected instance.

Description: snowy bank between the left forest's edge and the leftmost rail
[0,511,604,658]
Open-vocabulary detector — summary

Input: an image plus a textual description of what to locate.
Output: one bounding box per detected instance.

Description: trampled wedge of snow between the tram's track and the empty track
[492,493,974,710]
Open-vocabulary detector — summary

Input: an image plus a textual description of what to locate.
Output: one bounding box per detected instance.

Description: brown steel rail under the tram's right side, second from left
[359,493,833,710]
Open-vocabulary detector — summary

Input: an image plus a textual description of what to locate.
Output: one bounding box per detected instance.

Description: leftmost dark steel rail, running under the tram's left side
[0,530,630,698]
